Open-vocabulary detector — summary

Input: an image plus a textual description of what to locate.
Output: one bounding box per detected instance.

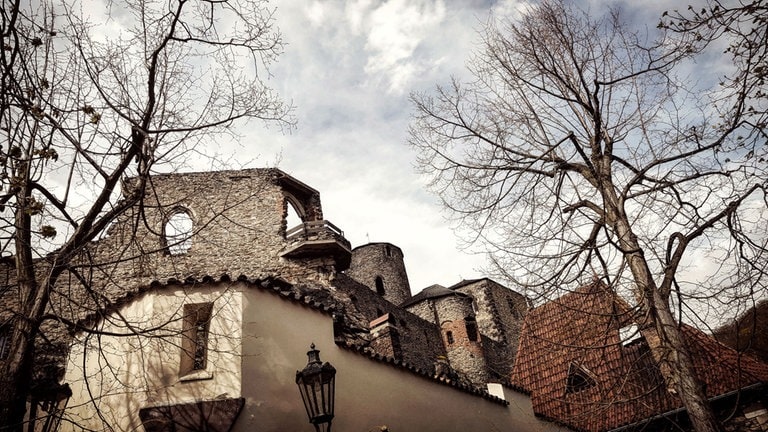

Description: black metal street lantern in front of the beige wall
[296,344,336,432]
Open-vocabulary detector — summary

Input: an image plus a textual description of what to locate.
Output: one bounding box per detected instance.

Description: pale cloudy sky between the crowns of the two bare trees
[186,0,680,294]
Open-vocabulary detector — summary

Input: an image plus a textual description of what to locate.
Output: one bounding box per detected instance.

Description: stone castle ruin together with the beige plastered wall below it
[0,169,559,431]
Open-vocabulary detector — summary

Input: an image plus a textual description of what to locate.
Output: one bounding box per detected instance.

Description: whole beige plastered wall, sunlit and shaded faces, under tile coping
[62,283,558,432]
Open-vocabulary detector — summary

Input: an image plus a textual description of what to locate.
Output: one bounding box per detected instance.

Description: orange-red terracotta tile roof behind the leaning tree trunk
[511,284,768,431]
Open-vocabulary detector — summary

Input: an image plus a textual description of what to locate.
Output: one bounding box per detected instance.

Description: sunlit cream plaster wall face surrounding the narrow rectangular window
[61,283,242,431]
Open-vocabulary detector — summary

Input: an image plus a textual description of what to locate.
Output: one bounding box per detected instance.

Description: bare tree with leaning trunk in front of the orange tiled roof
[410,1,768,431]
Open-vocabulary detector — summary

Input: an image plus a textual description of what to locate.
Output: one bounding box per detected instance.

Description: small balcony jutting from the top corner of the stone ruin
[280,220,352,271]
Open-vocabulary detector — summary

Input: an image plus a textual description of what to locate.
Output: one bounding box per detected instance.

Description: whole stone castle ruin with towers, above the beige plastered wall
[0,169,528,400]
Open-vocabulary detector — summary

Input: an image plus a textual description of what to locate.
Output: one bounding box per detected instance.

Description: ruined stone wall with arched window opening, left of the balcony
[0,169,342,388]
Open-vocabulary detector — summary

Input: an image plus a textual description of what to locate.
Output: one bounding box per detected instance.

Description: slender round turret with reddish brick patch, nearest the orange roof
[434,291,488,384]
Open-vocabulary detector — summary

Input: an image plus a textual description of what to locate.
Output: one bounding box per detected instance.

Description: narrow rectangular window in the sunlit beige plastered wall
[180,303,213,375]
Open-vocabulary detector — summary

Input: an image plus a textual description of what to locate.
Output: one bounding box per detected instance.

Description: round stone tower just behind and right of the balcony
[347,243,411,305]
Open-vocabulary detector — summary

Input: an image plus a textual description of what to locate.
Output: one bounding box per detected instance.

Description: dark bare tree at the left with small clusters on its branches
[0,0,292,430]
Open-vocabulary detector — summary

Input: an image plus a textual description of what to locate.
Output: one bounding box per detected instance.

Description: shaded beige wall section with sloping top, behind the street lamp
[234,290,560,432]
